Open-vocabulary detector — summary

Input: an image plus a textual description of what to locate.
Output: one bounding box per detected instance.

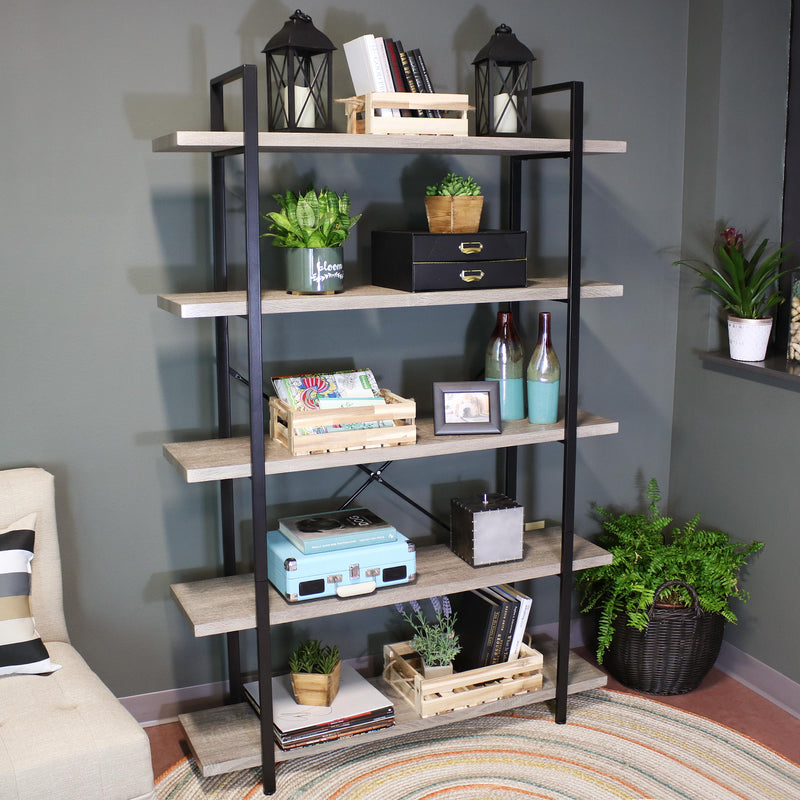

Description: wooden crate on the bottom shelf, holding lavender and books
[383,642,543,717]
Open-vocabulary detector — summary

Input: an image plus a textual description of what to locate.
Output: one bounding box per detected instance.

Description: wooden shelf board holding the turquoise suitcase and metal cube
[172,527,611,636]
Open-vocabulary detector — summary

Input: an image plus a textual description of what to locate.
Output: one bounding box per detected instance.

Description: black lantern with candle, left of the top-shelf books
[261,9,336,131]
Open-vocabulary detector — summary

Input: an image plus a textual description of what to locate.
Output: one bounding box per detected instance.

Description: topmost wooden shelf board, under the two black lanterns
[153,131,628,157]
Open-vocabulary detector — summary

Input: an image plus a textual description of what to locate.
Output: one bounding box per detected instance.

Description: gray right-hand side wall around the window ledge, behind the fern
[670,0,800,681]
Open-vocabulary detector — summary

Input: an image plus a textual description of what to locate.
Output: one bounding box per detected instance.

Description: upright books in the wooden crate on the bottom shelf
[453,583,533,672]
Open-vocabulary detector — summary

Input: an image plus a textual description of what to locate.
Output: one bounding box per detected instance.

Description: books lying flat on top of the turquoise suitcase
[278,508,397,553]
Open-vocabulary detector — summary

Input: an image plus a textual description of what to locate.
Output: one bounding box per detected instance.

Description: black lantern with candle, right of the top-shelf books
[472,25,536,136]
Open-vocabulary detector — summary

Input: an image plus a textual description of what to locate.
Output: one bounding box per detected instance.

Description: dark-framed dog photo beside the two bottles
[433,381,502,436]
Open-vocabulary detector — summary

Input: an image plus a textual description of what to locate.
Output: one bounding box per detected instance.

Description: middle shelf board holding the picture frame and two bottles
[164,411,619,483]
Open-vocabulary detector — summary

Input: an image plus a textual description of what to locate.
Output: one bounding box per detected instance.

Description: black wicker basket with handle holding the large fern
[603,581,725,695]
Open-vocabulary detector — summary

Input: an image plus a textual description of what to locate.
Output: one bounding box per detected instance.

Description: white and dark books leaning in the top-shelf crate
[343,33,441,117]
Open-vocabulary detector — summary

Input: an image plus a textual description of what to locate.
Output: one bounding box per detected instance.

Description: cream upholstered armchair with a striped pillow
[0,469,155,800]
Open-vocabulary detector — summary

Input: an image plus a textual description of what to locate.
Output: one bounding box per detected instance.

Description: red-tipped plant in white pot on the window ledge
[674,227,789,361]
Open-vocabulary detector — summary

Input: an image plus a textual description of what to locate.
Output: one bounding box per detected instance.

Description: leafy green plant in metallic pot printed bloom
[261,188,361,294]
